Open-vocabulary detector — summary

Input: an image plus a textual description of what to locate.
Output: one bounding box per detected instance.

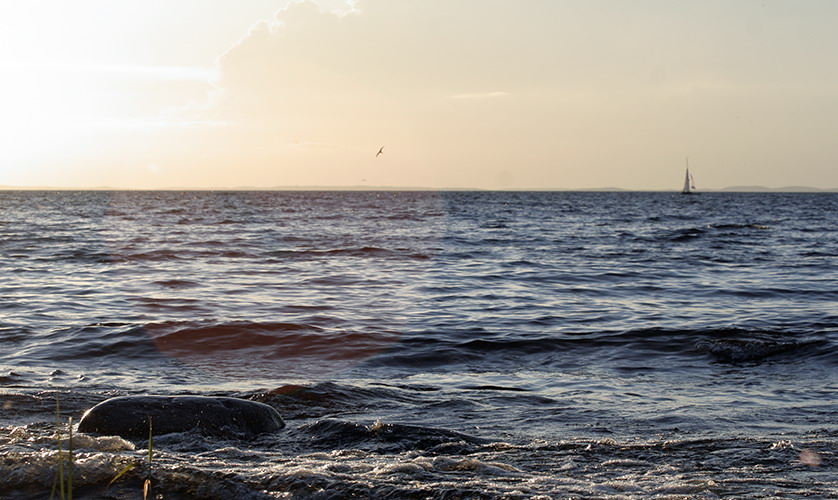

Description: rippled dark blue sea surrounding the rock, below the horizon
[0,191,838,500]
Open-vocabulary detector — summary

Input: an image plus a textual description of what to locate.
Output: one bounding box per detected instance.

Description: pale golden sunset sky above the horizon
[0,0,838,190]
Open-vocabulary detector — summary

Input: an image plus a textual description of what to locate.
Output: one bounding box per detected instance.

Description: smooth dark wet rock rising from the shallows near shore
[79,396,285,438]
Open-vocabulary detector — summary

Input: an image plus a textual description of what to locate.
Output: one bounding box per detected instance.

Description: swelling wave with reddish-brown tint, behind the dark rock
[3,321,398,371]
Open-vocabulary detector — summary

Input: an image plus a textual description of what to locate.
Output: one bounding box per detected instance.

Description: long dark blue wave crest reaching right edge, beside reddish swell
[371,328,838,369]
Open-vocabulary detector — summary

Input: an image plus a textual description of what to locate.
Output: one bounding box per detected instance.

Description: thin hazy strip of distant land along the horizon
[0,186,838,193]
